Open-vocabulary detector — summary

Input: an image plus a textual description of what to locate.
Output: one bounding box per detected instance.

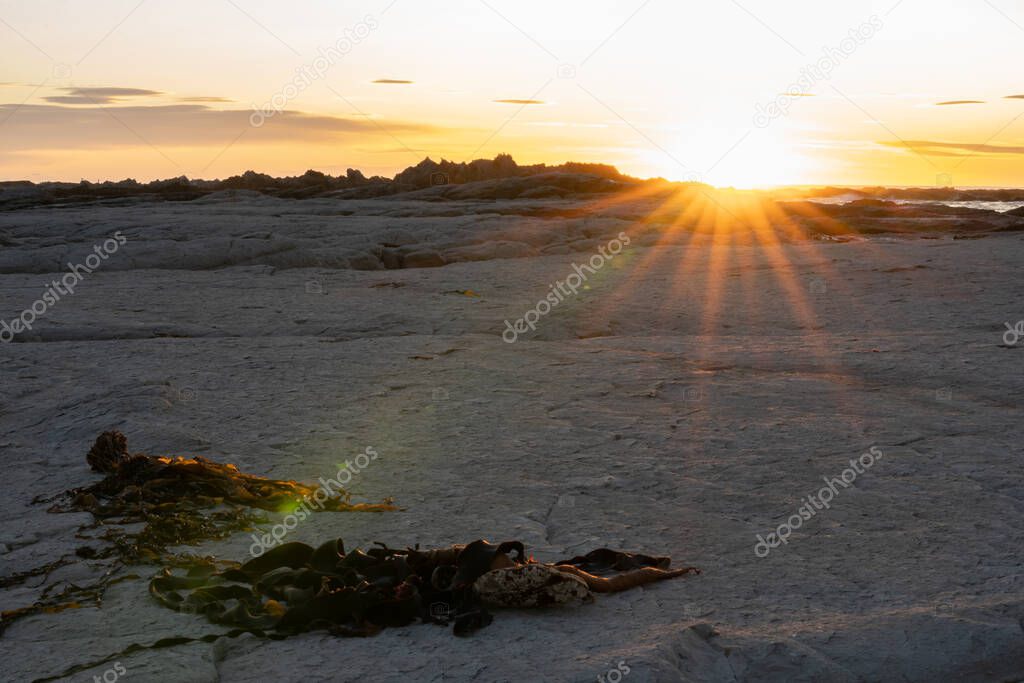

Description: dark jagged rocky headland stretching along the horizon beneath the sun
[0,155,1024,241]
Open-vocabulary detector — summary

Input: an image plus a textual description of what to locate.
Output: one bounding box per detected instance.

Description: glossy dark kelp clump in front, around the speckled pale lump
[150,539,699,637]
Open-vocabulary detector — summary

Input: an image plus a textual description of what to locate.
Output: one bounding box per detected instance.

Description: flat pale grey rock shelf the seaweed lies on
[0,179,1024,683]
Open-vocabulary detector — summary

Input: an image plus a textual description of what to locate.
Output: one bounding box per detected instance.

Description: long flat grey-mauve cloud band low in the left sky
[0,103,433,151]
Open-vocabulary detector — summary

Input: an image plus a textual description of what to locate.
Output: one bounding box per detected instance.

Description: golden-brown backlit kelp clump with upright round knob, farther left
[0,431,397,634]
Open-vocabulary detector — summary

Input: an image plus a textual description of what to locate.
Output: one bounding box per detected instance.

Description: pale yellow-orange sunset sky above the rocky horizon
[0,0,1024,187]
